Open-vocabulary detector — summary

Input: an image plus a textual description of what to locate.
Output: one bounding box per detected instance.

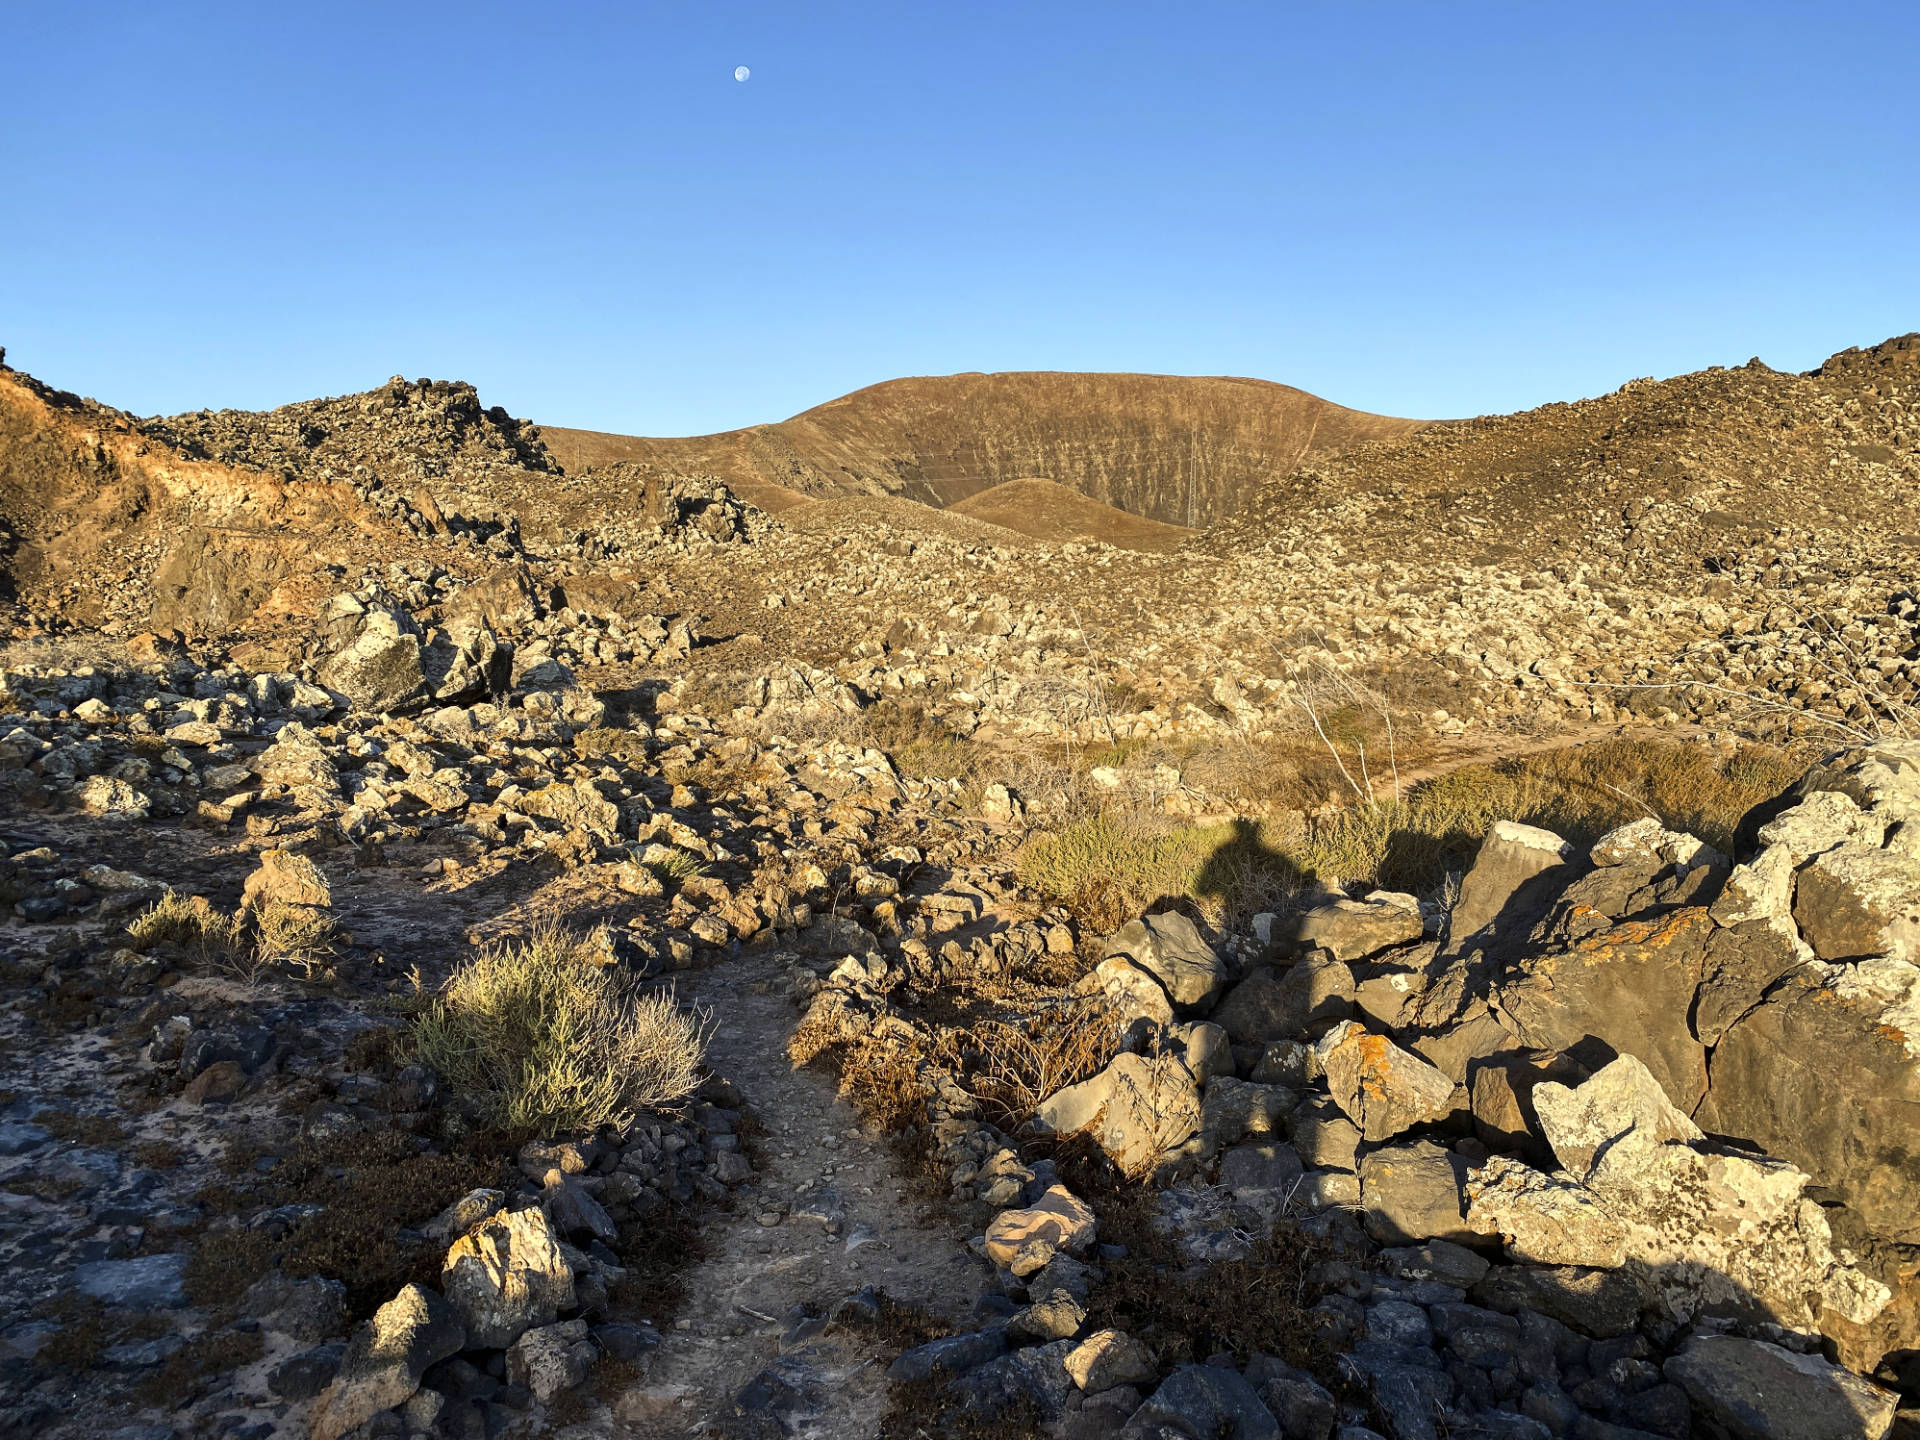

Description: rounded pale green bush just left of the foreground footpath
[413,929,707,1135]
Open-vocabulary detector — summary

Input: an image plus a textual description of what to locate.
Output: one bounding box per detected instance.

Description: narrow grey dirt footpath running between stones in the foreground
[606,956,985,1440]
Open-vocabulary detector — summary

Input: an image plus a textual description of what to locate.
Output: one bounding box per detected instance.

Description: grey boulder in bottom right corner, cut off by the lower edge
[1665,1334,1899,1440]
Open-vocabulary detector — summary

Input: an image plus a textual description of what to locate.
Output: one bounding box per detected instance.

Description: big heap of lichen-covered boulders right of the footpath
[787,743,1920,1440]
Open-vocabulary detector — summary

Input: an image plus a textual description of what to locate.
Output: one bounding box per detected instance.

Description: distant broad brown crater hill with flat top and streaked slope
[541,371,1423,524]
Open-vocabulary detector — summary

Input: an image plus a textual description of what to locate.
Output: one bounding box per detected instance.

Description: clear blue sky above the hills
[0,0,1920,434]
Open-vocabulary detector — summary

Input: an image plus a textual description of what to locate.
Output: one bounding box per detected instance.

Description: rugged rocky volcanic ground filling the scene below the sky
[0,338,1920,1440]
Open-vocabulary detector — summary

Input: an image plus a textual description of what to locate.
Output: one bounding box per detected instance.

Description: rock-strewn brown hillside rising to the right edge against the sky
[1202,336,1920,564]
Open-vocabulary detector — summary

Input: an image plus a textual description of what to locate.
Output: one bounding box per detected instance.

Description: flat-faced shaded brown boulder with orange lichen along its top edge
[1494,908,1713,1110]
